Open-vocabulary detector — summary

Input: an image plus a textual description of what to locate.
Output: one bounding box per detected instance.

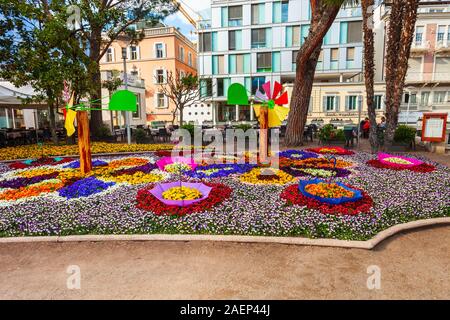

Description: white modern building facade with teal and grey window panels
[198,0,363,123]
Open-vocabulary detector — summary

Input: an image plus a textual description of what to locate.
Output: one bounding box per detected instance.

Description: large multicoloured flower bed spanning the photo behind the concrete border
[0,152,450,240]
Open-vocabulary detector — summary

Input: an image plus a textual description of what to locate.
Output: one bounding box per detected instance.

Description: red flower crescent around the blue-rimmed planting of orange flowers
[280,185,373,215]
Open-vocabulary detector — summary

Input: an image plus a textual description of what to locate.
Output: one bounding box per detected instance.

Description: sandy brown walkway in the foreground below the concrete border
[0,227,450,299]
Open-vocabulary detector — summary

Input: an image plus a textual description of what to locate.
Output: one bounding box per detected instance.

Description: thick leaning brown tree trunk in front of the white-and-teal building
[285,0,346,146]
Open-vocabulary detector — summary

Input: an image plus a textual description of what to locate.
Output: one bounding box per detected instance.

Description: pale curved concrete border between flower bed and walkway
[0,217,450,250]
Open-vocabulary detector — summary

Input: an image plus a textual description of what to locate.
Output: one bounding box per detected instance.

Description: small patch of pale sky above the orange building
[164,0,211,41]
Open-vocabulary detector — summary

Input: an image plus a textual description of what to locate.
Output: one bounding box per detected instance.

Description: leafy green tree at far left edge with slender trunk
[0,0,89,142]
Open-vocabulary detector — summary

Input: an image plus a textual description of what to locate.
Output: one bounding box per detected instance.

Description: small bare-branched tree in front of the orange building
[155,71,201,125]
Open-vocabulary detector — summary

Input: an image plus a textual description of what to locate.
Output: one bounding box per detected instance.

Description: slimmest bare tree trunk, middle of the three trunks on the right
[358,0,380,153]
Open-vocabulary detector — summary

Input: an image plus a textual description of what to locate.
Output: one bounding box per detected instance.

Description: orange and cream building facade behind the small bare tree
[100,27,197,125]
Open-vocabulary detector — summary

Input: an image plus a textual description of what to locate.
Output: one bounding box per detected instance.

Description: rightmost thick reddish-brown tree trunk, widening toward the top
[385,0,420,147]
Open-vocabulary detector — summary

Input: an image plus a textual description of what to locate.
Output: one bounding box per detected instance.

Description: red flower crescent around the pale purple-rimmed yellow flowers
[136,183,233,216]
